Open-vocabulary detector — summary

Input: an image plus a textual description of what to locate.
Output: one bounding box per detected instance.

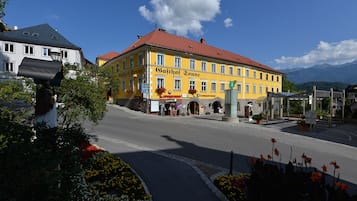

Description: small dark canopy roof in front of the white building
[17,57,62,80]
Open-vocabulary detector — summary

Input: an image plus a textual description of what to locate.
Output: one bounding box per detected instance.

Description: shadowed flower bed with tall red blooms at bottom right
[214,138,357,201]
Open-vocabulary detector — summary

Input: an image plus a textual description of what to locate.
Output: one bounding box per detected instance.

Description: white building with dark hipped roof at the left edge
[0,24,86,80]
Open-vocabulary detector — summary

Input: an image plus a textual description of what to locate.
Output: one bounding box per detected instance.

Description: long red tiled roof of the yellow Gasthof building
[120,29,281,73]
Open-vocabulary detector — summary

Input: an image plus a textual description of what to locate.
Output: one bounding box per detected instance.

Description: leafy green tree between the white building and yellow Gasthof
[55,66,106,127]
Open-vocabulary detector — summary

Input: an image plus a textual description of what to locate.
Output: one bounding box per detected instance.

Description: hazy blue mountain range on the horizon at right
[280,60,357,84]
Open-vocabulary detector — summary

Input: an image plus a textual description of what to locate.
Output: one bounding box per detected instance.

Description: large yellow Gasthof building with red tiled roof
[103,29,282,116]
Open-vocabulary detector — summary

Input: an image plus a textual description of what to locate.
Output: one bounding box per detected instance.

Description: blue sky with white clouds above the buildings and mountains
[3,0,357,69]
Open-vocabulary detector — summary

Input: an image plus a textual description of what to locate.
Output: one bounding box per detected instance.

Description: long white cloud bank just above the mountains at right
[275,39,357,67]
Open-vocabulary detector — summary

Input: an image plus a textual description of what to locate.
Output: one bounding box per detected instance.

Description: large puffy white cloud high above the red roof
[139,0,221,36]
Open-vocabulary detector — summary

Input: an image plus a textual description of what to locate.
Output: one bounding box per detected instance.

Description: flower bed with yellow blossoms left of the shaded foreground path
[83,145,151,200]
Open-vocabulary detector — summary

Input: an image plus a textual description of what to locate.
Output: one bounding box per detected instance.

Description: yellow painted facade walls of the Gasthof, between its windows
[107,48,282,102]
